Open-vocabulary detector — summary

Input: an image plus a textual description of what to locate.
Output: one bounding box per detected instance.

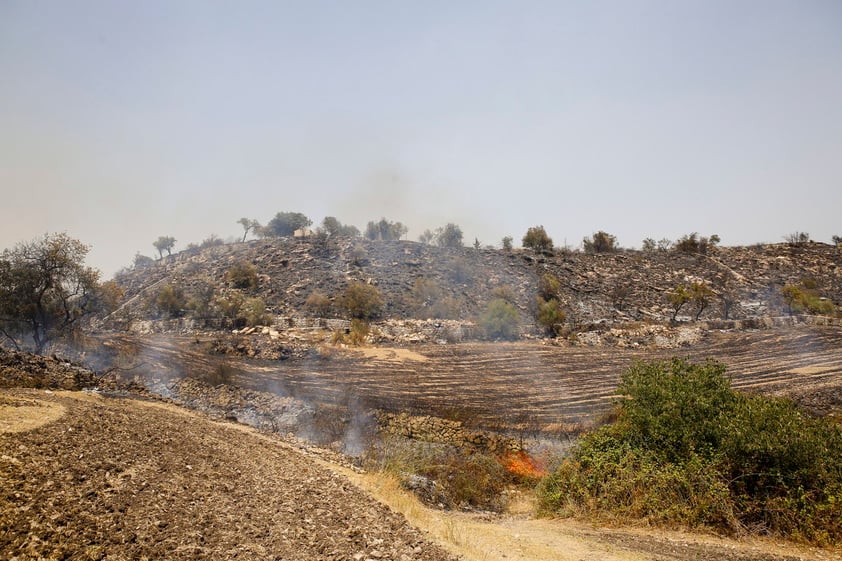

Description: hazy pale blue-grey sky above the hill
[0,0,842,276]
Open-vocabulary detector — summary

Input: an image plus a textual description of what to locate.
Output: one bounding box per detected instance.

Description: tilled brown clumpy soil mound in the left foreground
[0,389,455,561]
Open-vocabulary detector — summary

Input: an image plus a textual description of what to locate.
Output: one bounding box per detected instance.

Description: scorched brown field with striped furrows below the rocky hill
[105,325,842,430]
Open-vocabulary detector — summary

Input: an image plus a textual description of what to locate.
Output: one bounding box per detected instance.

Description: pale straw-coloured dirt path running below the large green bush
[333,468,842,561]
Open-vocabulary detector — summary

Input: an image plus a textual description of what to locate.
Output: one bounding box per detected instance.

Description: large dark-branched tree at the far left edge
[0,233,104,354]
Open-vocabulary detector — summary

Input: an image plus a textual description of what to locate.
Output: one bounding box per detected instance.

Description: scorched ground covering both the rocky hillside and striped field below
[95,239,842,432]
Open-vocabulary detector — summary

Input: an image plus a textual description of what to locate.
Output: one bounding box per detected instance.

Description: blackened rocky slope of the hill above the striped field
[104,239,842,332]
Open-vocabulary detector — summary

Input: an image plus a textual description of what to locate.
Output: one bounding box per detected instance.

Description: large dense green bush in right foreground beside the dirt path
[540,359,842,544]
